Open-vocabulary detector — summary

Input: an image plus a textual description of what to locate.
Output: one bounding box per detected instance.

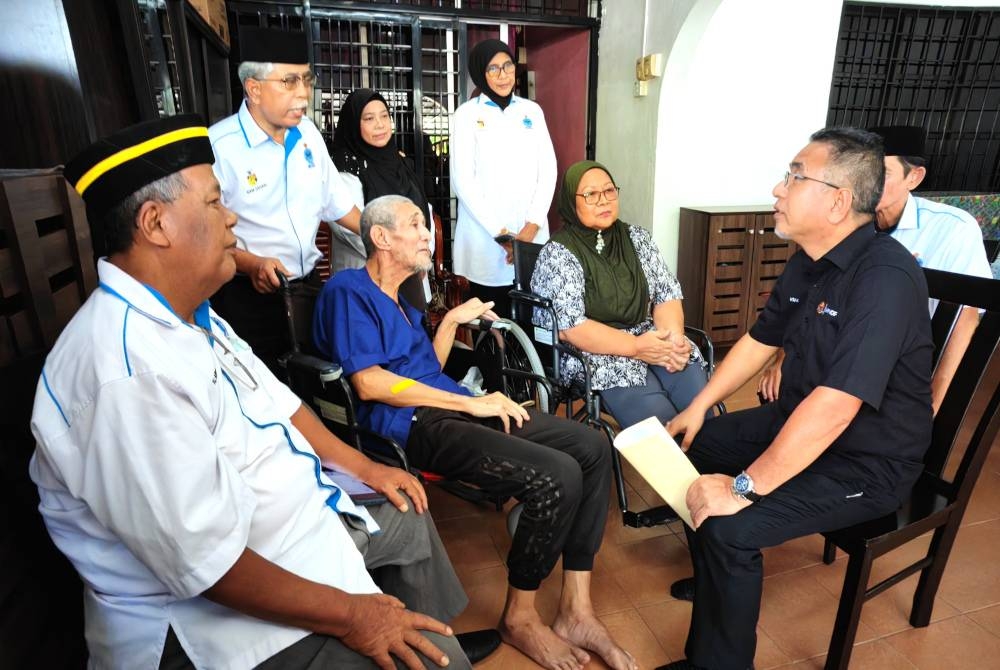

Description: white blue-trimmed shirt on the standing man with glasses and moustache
[208,100,354,278]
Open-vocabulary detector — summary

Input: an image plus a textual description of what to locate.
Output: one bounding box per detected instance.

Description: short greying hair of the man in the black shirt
[809,128,885,216]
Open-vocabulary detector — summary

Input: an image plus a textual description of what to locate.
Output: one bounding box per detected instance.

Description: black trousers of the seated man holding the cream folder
[684,403,899,670]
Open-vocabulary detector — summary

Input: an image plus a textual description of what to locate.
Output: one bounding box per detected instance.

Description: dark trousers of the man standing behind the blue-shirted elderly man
[211,272,318,379]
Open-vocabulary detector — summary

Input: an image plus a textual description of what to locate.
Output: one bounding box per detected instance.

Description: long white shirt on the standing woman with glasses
[448,95,556,286]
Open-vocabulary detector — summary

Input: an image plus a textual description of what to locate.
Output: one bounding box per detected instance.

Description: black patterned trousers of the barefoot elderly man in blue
[406,407,611,591]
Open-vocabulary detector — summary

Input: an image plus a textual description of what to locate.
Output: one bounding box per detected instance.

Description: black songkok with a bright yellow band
[63,114,215,217]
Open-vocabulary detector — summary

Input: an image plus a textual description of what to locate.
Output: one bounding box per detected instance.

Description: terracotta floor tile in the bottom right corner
[884,616,1000,670]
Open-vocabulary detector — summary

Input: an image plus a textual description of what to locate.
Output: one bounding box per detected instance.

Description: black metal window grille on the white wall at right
[827,3,1000,192]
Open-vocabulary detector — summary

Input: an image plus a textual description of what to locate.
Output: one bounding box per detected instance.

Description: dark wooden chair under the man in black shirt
[823,270,1000,670]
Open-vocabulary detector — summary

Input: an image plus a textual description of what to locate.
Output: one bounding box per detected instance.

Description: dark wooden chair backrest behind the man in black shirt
[924,269,1000,501]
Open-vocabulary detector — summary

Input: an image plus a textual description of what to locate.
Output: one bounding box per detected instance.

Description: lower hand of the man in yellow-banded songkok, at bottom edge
[337,593,452,670]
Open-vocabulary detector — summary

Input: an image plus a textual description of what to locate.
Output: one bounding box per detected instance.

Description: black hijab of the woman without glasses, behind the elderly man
[331,88,430,216]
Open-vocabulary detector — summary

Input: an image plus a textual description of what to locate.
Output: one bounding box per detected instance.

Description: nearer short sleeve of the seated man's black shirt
[820,265,928,410]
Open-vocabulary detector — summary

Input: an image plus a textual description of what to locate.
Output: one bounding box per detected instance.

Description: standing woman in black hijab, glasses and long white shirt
[449,40,556,317]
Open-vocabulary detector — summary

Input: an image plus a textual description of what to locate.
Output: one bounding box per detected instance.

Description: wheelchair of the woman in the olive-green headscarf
[504,240,726,528]
